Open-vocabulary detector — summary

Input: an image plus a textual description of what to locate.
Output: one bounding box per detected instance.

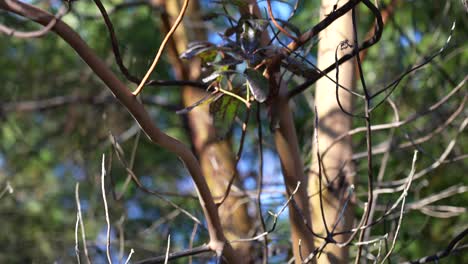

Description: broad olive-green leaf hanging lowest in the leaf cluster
[210,95,241,138]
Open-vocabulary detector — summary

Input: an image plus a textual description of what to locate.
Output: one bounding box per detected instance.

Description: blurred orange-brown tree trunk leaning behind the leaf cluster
[156,0,252,263]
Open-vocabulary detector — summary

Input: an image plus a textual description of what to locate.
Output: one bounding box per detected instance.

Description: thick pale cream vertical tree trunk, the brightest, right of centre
[308,0,354,263]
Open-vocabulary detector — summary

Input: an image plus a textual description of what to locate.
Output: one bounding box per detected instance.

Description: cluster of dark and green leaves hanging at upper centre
[178,17,273,137]
